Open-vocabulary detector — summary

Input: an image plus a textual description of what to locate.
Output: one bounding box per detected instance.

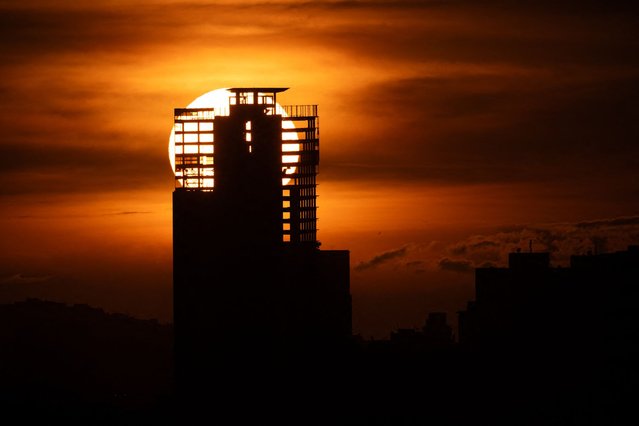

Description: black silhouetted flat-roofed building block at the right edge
[458,246,639,425]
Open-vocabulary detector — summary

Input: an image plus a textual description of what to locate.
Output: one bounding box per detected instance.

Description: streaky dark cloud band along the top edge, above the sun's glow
[0,1,638,68]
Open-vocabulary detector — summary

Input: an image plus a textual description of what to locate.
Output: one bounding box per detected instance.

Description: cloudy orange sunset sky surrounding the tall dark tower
[0,0,639,336]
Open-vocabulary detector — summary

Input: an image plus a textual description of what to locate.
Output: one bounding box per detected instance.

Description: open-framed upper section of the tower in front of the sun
[173,87,319,246]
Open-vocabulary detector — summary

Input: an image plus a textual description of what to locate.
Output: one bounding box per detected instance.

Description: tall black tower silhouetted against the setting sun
[173,88,351,402]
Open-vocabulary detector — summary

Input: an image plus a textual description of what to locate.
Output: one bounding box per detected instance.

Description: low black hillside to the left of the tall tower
[0,299,173,424]
